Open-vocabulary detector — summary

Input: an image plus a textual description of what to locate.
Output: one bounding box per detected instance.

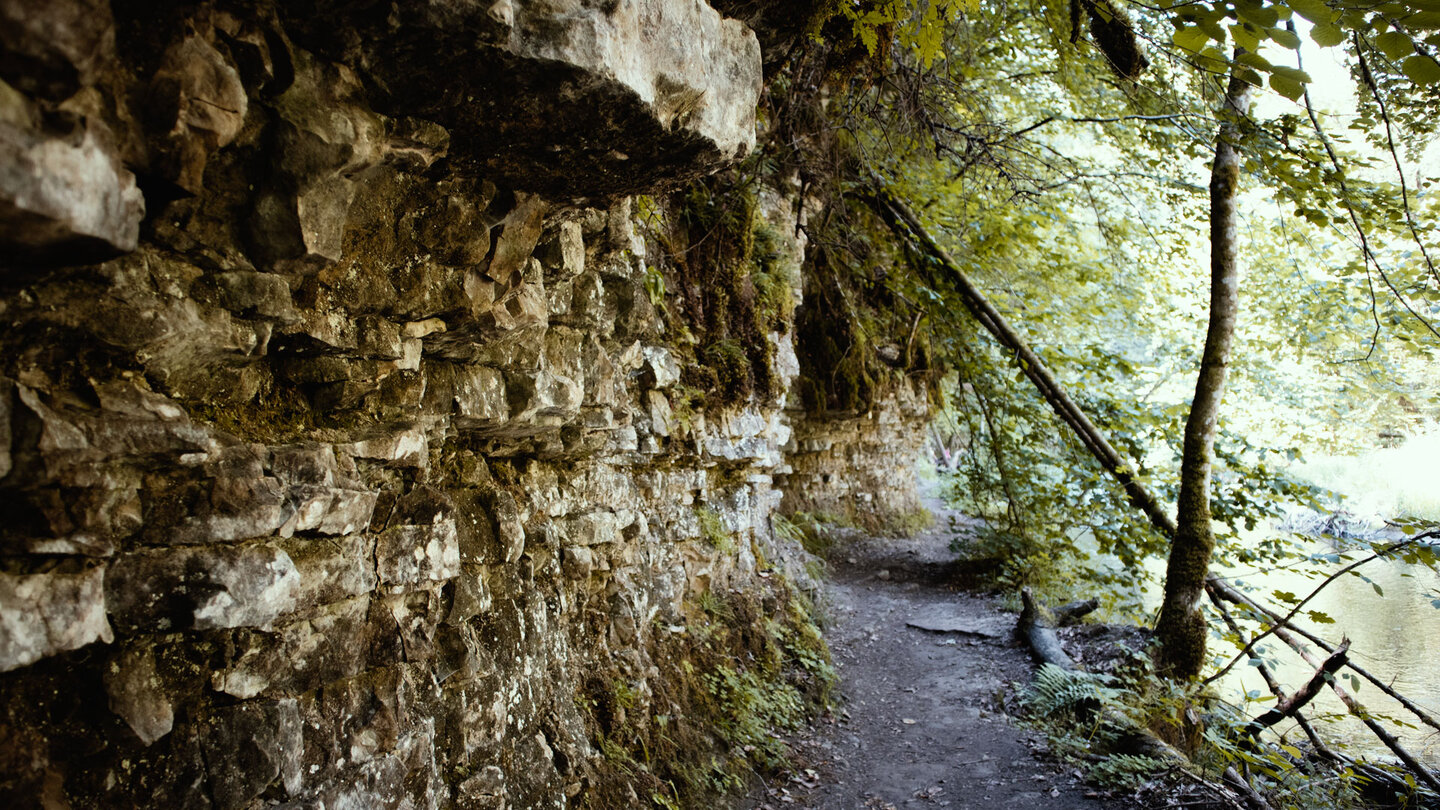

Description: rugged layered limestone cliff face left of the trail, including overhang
[0,0,915,809]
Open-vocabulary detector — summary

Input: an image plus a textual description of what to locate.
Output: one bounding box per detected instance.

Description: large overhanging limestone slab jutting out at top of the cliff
[282,0,762,199]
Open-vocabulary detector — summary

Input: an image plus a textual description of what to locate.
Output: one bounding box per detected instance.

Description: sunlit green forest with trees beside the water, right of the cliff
[757,0,1440,790]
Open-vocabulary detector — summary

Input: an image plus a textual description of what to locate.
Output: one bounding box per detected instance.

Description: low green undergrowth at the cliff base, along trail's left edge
[577,572,837,810]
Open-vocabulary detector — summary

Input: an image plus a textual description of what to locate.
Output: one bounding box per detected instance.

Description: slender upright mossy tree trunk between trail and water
[1155,66,1250,679]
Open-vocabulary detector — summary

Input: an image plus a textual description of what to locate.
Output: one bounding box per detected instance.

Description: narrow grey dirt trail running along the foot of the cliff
[746,504,1125,810]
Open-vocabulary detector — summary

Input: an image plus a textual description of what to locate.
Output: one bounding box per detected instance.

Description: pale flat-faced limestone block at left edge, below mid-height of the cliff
[0,568,114,672]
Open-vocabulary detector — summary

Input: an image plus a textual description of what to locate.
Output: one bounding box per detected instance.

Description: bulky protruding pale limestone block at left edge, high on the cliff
[0,110,145,262]
